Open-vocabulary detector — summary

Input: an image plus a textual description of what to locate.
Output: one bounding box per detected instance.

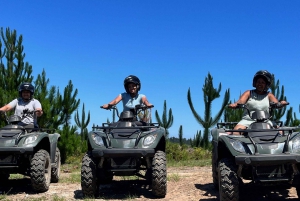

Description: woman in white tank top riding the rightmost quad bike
[228,70,288,134]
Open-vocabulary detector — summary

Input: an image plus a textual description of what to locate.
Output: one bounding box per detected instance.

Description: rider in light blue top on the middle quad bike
[102,75,152,111]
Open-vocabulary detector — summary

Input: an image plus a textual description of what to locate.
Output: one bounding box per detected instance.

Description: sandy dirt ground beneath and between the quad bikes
[0,167,298,201]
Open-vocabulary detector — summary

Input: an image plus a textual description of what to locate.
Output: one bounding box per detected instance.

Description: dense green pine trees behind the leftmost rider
[0,28,87,162]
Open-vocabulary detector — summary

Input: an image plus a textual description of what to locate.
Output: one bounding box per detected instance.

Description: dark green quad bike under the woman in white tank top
[211,103,300,201]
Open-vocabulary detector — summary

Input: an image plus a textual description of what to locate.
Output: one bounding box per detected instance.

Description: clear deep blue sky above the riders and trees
[0,0,300,138]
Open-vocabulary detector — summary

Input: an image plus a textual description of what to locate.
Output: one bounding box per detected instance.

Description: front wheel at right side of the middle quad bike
[152,151,167,197]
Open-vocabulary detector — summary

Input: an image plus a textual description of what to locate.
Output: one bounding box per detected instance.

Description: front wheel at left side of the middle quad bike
[81,154,98,197]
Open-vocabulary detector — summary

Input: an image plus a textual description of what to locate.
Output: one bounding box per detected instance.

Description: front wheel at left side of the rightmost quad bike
[218,158,240,201]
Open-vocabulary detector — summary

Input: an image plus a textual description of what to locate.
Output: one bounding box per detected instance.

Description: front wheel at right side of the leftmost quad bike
[30,149,51,192]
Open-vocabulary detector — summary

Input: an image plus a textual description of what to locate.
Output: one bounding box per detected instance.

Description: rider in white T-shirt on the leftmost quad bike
[0,82,43,127]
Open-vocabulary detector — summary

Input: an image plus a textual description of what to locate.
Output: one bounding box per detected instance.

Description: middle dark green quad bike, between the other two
[81,105,167,197]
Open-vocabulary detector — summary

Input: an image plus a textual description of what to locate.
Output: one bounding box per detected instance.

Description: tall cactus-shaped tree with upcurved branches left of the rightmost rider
[187,73,230,148]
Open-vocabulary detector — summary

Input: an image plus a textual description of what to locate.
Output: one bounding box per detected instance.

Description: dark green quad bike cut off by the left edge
[0,110,61,192]
